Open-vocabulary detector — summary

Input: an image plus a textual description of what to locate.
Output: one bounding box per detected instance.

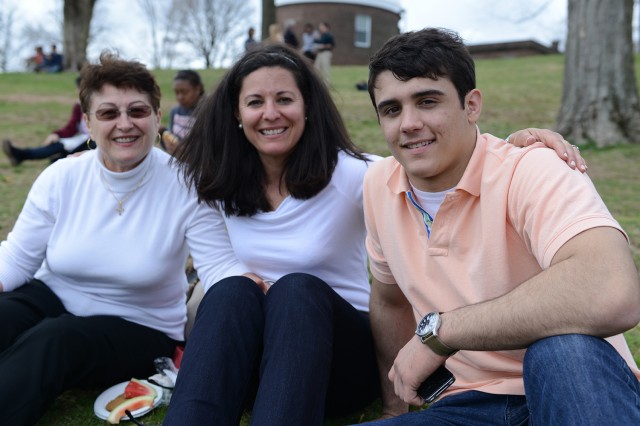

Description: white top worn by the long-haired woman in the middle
[212,152,379,312]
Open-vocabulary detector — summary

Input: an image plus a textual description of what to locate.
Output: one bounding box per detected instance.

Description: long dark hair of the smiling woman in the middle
[176,45,366,216]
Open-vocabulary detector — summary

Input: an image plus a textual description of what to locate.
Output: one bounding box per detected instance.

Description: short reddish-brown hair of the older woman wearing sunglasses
[80,50,160,112]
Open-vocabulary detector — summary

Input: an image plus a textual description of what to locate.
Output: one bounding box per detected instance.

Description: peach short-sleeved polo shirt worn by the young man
[364,134,640,395]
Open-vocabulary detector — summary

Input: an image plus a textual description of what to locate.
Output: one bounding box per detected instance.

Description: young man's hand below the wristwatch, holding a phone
[388,337,447,407]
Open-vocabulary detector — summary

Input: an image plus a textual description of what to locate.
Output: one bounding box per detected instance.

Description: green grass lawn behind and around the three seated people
[0,55,640,426]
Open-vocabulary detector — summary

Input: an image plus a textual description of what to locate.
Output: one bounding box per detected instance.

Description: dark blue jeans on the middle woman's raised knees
[164,273,380,425]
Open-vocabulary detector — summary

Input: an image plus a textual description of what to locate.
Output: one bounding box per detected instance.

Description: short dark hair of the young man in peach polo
[368,28,476,111]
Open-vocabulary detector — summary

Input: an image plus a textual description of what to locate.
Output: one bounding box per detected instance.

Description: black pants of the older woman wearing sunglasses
[0,280,176,426]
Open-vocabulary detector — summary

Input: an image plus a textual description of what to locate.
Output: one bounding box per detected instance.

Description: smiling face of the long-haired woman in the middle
[238,67,305,163]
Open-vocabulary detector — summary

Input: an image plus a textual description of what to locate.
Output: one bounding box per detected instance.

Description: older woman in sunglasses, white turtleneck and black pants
[0,52,241,425]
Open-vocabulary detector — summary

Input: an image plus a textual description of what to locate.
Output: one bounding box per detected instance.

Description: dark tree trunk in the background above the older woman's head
[63,0,96,71]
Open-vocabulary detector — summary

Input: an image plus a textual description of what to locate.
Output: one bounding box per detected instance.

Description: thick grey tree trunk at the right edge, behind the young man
[557,0,640,147]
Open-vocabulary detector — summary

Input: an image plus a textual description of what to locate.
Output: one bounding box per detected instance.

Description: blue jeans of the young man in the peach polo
[364,334,640,426]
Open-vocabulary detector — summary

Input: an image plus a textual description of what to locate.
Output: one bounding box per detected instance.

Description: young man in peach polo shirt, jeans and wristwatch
[364,29,640,426]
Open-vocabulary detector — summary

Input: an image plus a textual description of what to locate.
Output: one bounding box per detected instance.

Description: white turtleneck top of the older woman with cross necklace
[0,148,248,340]
